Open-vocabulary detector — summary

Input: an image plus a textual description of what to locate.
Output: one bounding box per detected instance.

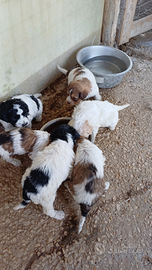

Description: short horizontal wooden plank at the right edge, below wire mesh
[130,14,152,37]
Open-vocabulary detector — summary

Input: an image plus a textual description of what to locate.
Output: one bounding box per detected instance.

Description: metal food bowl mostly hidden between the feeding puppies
[40,117,94,143]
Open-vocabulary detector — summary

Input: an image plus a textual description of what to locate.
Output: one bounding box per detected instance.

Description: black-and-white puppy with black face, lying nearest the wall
[0,94,43,131]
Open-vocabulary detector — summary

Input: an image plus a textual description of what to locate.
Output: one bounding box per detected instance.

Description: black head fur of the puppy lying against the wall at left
[0,98,29,127]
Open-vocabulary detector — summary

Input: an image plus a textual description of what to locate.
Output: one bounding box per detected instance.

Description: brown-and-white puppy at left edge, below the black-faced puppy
[0,128,50,166]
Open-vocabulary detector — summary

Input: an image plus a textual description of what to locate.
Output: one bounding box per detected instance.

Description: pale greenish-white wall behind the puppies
[0,0,104,100]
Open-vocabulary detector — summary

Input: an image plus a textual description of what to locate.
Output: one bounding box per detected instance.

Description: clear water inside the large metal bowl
[83,55,126,75]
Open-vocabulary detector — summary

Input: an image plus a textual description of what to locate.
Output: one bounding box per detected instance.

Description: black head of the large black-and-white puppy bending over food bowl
[50,124,80,143]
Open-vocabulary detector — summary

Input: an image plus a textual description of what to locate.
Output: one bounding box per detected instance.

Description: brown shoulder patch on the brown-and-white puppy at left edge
[19,128,37,152]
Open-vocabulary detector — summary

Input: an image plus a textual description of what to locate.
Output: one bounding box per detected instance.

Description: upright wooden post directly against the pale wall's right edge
[101,0,121,46]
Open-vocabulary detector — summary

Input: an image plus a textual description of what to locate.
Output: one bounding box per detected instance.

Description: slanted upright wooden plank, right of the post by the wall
[116,0,137,45]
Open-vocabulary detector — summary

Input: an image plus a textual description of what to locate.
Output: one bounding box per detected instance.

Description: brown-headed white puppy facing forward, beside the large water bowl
[58,66,101,106]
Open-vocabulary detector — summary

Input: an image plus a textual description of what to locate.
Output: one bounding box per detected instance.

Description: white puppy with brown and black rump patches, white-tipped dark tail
[64,137,109,233]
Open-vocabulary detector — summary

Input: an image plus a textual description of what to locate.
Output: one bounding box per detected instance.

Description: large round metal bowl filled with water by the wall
[76,46,132,88]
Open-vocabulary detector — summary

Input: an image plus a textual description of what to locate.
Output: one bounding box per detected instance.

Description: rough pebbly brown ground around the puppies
[0,32,152,270]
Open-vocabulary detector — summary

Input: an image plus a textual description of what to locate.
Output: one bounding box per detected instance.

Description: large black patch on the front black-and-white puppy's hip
[23,169,49,201]
